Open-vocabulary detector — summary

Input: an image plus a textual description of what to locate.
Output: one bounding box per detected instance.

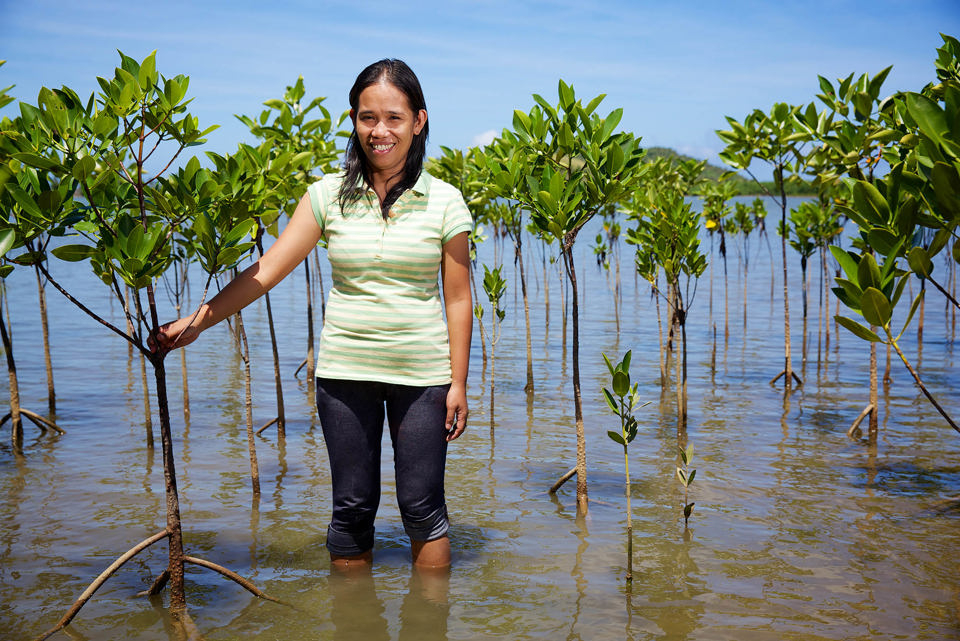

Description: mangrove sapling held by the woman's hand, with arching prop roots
[9,53,284,638]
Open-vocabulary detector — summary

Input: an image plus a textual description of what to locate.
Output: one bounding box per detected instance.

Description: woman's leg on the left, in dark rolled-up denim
[317,378,384,568]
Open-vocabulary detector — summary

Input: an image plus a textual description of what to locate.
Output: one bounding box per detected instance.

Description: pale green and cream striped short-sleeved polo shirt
[307,172,473,386]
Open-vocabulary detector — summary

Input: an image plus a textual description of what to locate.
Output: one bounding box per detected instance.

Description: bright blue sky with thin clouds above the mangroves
[0,0,960,178]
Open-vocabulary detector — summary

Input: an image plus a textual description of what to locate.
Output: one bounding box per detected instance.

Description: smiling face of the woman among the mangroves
[350,82,427,179]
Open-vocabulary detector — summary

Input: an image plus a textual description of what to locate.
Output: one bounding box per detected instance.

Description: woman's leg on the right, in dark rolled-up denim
[386,385,450,567]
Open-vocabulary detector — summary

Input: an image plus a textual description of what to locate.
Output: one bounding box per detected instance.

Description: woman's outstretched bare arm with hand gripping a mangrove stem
[154,194,323,351]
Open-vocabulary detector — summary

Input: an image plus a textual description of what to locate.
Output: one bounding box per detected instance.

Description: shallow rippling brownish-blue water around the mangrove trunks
[0,198,960,641]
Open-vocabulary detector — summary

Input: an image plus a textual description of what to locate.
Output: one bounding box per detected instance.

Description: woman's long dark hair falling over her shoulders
[337,59,430,218]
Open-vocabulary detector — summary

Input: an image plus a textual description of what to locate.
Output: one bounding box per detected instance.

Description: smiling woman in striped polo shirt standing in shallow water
[156,60,472,568]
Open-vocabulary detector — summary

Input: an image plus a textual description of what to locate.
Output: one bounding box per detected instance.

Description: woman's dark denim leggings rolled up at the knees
[317,378,450,556]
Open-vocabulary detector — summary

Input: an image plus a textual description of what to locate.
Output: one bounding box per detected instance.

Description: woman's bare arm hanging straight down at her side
[440,232,473,441]
